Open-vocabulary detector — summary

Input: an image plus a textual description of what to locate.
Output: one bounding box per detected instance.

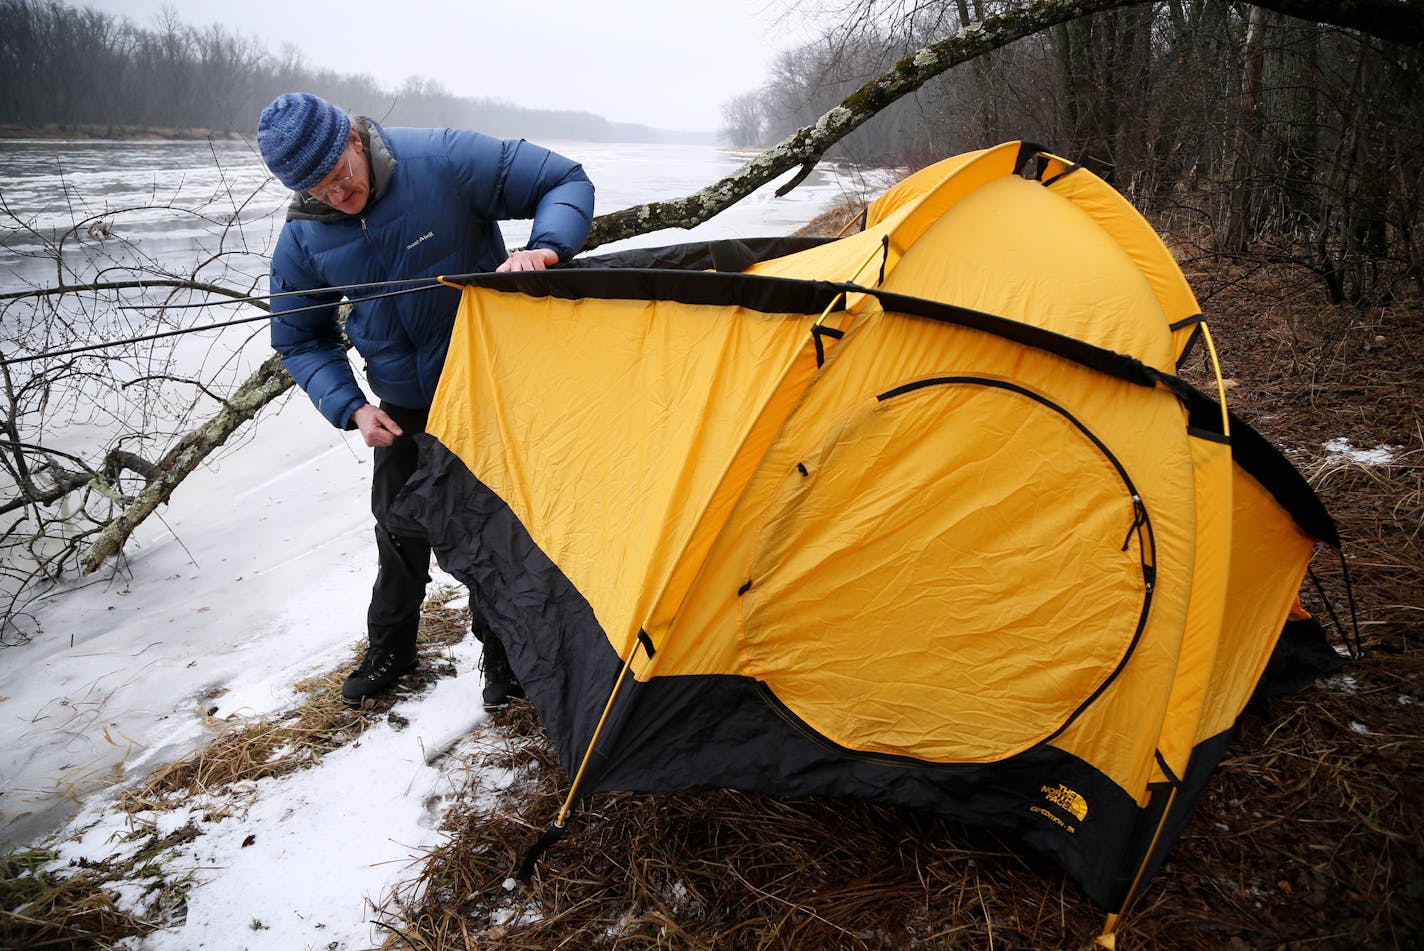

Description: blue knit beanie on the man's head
[258,93,352,192]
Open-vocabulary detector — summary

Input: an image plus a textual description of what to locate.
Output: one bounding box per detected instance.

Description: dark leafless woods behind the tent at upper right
[740,0,1424,293]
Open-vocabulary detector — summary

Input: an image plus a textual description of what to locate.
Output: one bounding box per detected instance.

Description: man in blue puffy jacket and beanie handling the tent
[258,93,594,710]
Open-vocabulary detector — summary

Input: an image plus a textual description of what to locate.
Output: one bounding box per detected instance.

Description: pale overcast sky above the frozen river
[86,0,831,131]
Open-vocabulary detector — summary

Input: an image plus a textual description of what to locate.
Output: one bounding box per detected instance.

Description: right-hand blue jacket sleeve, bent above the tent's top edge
[447,130,594,261]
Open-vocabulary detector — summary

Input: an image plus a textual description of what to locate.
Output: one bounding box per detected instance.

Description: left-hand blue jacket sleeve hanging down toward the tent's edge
[269,229,367,430]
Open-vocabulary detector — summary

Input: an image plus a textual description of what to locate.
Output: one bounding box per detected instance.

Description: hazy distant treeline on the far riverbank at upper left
[0,0,711,142]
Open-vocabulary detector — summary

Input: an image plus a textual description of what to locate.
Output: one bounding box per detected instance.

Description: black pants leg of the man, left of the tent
[366,403,430,653]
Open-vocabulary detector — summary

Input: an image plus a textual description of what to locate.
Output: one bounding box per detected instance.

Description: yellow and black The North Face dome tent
[395,142,1337,911]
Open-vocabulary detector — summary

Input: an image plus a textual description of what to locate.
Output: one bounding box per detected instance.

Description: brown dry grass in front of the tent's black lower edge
[375,705,1101,951]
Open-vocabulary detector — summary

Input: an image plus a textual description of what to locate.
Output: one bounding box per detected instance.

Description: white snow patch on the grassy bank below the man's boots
[115,639,486,951]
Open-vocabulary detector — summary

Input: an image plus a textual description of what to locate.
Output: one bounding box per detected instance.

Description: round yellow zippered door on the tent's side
[742,377,1152,763]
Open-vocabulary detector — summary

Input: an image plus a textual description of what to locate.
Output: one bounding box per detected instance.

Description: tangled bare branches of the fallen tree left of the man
[0,140,290,643]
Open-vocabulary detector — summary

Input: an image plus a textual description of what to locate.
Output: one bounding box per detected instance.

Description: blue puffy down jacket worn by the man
[271,117,594,429]
